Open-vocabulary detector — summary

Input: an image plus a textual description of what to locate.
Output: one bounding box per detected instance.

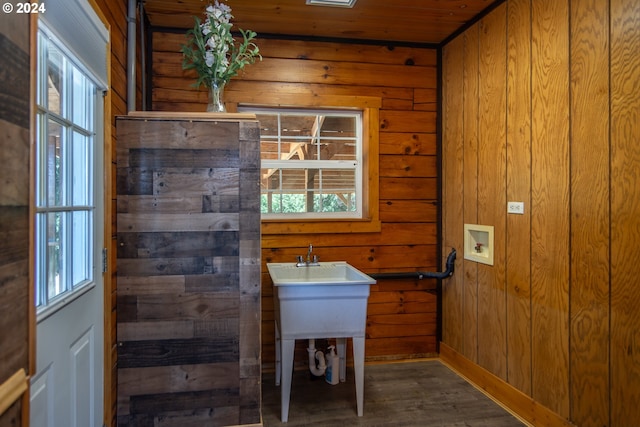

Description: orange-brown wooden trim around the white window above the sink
[231,90,382,235]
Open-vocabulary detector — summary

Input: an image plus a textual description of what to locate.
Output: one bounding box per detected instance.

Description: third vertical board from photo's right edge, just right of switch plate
[531,0,570,417]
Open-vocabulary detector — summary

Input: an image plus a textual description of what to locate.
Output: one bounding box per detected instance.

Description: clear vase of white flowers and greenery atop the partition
[182,0,262,112]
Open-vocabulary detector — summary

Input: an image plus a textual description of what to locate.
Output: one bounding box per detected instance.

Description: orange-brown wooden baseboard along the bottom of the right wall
[440,343,575,427]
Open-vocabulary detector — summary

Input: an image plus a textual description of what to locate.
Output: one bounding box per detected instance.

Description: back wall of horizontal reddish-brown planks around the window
[152,32,438,369]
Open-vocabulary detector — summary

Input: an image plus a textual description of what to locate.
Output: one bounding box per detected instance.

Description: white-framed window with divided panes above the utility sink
[244,108,363,219]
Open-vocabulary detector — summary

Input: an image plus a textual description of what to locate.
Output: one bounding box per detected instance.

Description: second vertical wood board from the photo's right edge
[569,0,610,426]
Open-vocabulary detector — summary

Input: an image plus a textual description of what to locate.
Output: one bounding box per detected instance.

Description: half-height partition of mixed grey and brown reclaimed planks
[116,113,260,426]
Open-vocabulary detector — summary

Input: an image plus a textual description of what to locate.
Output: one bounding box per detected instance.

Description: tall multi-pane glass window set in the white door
[35,24,98,312]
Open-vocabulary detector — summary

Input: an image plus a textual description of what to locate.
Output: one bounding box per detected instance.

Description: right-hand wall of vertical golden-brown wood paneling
[442,0,640,426]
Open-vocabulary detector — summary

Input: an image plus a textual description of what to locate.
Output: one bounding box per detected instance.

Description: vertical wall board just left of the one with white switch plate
[477,4,507,379]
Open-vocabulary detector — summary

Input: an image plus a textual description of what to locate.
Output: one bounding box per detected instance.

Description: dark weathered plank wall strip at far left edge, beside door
[0,7,35,427]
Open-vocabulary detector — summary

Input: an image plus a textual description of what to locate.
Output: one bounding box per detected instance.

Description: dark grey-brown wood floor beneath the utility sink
[262,360,525,427]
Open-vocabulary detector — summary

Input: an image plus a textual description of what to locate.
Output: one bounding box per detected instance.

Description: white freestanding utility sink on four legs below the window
[267,262,376,422]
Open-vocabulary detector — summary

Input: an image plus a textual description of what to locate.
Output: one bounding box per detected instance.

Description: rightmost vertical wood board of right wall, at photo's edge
[609,0,640,425]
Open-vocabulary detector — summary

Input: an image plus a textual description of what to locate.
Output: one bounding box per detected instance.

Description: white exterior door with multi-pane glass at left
[30,25,105,427]
